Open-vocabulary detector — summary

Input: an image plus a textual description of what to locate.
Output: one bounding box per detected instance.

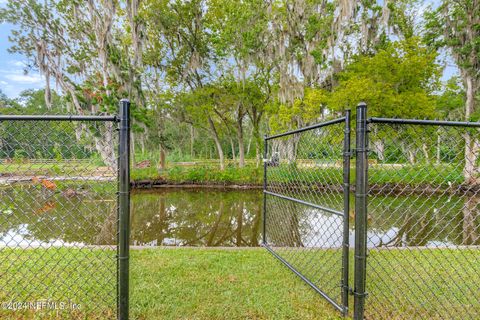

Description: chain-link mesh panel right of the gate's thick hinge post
[366,123,480,319]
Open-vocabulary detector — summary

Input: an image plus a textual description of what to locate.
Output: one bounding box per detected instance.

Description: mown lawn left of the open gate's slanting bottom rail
[0,248,340,319]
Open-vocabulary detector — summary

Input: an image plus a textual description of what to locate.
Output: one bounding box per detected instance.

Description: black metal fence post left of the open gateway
[117,99,130,320]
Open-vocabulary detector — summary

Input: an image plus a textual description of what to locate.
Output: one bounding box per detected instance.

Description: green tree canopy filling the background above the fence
[0,0,472,181]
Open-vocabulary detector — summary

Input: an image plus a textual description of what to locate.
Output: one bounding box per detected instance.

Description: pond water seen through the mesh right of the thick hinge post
[369,195,480,247]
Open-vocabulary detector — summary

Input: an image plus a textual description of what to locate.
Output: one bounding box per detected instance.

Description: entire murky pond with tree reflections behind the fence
[0,185,480,248]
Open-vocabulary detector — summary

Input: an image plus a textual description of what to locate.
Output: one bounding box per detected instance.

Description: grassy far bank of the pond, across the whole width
[0,162,464,186]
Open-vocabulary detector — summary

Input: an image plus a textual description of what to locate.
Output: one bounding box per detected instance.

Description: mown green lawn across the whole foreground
[0,248,480,320]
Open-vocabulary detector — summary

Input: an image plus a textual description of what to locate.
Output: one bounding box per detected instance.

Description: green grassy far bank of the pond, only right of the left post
[132,164,464,186]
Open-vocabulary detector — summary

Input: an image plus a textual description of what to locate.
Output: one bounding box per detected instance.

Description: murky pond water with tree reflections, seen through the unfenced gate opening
[132,189,262,246]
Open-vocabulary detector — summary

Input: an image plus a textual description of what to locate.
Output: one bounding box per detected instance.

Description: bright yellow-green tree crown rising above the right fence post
[329,38,441,118]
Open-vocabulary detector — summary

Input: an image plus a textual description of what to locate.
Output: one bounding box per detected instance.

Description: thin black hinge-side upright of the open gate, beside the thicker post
[342,110,351,316]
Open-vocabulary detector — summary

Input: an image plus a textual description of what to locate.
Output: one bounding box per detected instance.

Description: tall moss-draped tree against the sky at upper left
[0,0,148,166]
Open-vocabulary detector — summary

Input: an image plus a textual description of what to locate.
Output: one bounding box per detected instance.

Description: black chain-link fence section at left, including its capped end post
[0,100,129,319]
